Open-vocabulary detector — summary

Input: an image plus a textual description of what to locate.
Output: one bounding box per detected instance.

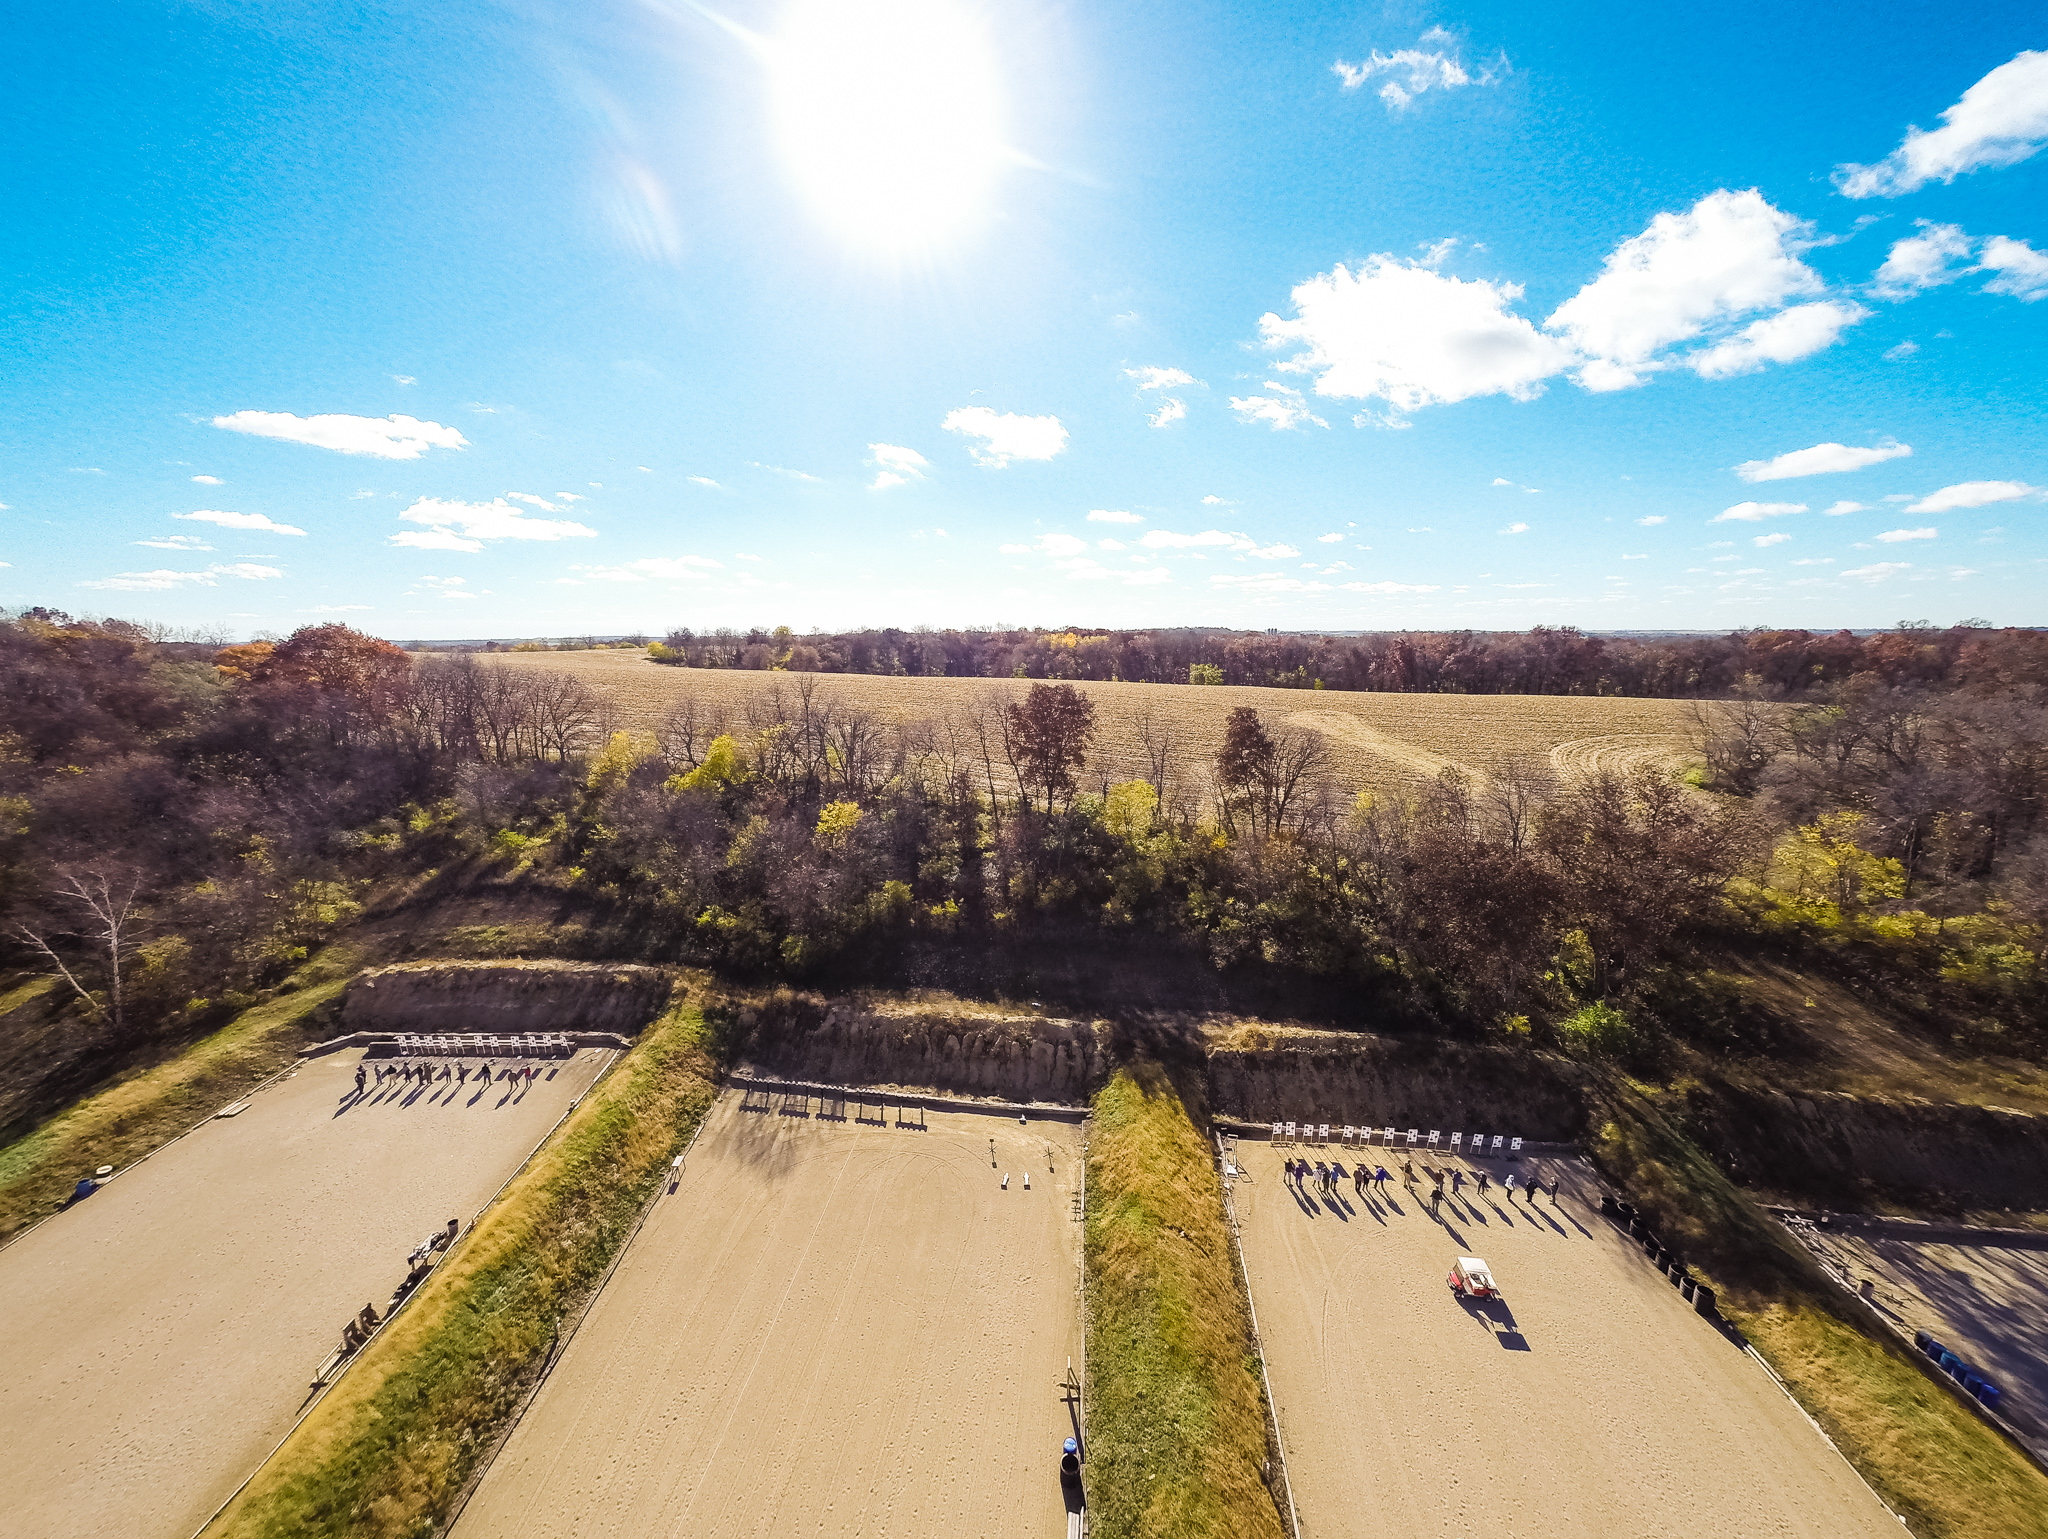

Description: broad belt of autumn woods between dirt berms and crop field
[0,613,2048,1059]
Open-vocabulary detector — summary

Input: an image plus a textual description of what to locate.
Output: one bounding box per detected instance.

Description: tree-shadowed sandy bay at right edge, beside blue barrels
[1823,1234,2048,1457]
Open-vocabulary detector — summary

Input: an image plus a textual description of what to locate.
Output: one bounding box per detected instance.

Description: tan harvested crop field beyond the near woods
[492,652,1696,789]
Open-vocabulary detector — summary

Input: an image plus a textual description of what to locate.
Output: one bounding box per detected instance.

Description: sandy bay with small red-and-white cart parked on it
[1235,1139,1901,1539]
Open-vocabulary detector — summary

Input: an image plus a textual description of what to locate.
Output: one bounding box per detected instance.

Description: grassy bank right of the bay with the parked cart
[1591,1084,2048,1539]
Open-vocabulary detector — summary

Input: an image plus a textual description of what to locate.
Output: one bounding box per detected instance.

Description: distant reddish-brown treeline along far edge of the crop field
[653,623,2048,699]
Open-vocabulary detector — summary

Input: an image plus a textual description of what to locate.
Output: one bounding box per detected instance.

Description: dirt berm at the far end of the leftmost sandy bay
[342,961,672,1035]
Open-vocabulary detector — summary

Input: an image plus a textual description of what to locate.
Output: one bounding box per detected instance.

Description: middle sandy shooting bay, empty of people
[457,1092,1081,1539]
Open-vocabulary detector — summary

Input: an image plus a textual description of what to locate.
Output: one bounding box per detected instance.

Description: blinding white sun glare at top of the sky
[770,0,1010,254]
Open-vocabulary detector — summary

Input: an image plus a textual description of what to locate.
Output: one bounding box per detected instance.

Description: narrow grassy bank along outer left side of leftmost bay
[0,953,354,1240]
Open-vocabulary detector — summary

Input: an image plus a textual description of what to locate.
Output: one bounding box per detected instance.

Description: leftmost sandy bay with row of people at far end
[0,1051,604,1539]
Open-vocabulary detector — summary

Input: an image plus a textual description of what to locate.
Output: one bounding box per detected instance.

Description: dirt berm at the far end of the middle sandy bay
[739,994,1112,1100]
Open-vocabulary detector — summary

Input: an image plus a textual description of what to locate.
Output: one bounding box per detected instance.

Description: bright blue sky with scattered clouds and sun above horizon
[0,0,2048,637]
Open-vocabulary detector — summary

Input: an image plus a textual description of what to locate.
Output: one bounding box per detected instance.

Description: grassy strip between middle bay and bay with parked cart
[1083,1064,1284,1539]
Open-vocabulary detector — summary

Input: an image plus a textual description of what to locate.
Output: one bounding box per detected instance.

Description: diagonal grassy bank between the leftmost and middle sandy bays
[215,1004,715,1539]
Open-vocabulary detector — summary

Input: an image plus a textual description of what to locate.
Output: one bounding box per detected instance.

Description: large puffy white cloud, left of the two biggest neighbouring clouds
[1231,252,1575,426]
